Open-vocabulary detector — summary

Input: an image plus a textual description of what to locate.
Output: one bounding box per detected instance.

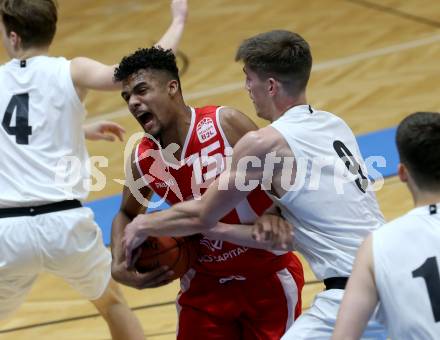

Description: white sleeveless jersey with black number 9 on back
[271,105,384,280]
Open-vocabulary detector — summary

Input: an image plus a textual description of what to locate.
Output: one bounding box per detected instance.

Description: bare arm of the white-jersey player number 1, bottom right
[332,235,378,340]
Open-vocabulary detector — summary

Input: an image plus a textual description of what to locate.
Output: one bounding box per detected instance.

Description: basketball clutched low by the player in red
[135,236,197,280]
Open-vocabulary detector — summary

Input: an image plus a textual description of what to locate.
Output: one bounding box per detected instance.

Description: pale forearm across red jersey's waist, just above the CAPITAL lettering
[203,223,286,250]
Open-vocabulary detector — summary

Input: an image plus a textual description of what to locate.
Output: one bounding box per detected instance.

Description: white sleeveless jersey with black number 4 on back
[0,56,88,208]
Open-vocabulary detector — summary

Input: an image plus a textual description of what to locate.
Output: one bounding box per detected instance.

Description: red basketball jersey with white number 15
[136,106,293,276]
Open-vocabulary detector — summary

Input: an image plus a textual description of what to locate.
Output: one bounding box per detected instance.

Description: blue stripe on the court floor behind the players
[86,128,399,245]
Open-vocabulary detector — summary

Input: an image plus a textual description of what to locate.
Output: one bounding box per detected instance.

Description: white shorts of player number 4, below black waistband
[0,208,111,319]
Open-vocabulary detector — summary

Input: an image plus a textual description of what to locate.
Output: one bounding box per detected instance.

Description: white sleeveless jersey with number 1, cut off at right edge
[373,204,440,340]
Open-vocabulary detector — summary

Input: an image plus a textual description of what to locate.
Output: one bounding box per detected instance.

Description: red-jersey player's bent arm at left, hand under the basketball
[111,152,173,289]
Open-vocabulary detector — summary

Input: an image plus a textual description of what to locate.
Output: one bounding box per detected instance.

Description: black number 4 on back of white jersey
[2,93,32,145]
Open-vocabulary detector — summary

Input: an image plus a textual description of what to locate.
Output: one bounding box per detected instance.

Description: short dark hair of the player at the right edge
[396,112,440,191]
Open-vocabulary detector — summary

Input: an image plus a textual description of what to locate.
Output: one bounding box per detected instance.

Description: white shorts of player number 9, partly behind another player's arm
[281,289,387,340]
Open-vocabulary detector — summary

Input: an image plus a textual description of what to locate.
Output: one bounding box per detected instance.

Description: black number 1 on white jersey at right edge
[412,256,440,322]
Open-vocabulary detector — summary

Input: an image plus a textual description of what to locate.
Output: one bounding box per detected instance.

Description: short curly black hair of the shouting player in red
[114,46,180,86]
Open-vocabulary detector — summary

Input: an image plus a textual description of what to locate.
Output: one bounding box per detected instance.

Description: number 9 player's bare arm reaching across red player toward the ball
[124,126,272,266]
